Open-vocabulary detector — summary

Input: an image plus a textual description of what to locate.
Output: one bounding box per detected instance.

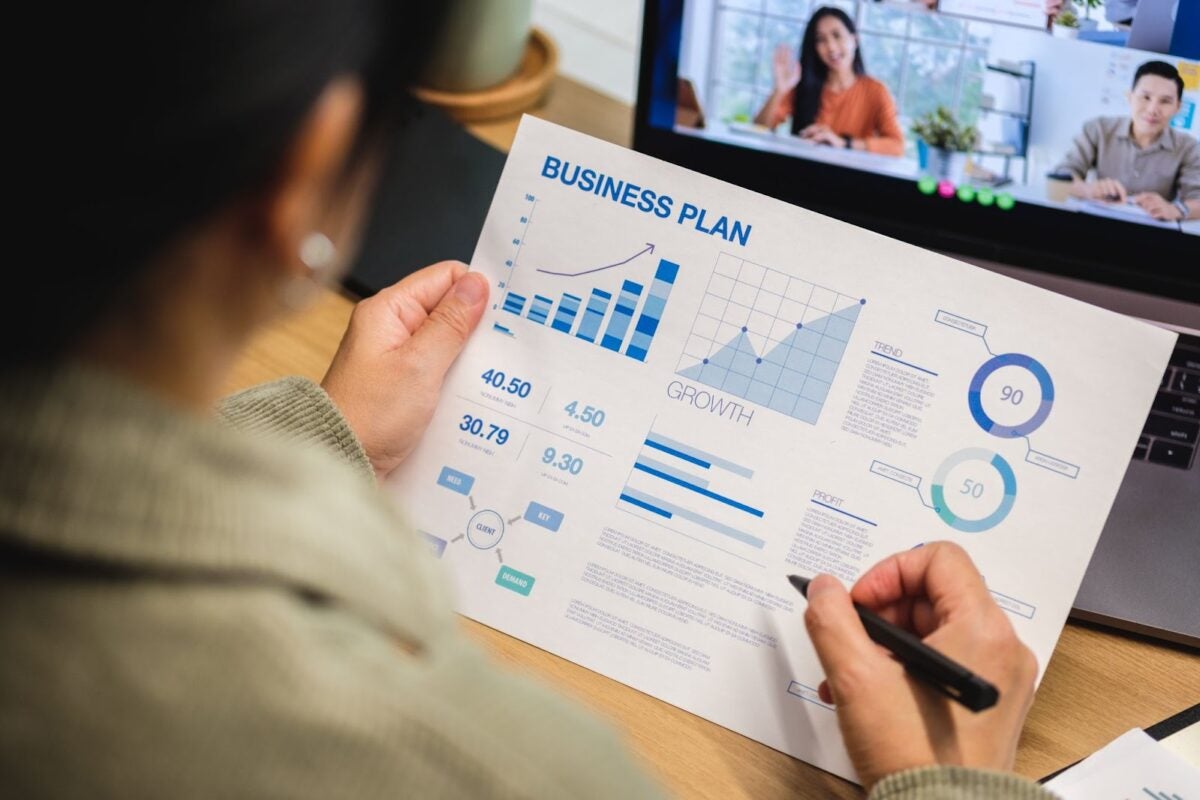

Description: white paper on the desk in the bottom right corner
[1045,728,1200,800]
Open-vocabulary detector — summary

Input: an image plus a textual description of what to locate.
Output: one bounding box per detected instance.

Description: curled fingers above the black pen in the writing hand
[851,542,991,627]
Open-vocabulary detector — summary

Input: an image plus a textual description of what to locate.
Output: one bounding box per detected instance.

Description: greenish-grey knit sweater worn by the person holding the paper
[0,367,1050,800]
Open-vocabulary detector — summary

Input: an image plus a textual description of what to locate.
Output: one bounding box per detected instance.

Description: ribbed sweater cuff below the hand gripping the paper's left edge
[218,378,374,481]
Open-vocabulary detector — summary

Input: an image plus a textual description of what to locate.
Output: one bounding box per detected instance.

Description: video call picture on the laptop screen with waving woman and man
[660,0,1200,233]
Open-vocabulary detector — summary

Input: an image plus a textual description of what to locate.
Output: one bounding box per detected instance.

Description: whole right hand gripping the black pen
[804,542,1037,789]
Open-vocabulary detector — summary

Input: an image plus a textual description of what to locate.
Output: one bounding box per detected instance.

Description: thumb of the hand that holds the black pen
[804,575,881,702]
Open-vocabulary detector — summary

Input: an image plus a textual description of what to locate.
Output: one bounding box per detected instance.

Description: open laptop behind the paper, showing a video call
[634,0,1200,646]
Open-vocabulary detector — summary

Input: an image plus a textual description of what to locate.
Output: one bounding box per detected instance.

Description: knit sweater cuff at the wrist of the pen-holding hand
[868,766,1056,800]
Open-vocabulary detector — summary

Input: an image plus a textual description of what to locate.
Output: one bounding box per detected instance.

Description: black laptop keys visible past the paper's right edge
[1133,333,1200,469]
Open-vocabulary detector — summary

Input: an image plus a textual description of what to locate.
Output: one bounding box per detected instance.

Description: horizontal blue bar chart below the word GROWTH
[618,431,767,552]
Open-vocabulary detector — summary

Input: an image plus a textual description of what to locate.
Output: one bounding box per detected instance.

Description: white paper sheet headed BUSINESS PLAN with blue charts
[390,118,1175,778]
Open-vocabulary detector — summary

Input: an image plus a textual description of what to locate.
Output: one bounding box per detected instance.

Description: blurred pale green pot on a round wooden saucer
[415,0,558,122]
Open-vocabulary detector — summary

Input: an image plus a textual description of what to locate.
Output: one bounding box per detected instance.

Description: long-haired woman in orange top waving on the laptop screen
[755,6,904,156]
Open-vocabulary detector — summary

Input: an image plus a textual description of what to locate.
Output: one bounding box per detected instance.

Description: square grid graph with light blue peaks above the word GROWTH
[676,253,866,423]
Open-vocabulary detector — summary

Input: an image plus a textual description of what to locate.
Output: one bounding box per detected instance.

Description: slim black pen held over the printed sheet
[787,575,1000,711]
